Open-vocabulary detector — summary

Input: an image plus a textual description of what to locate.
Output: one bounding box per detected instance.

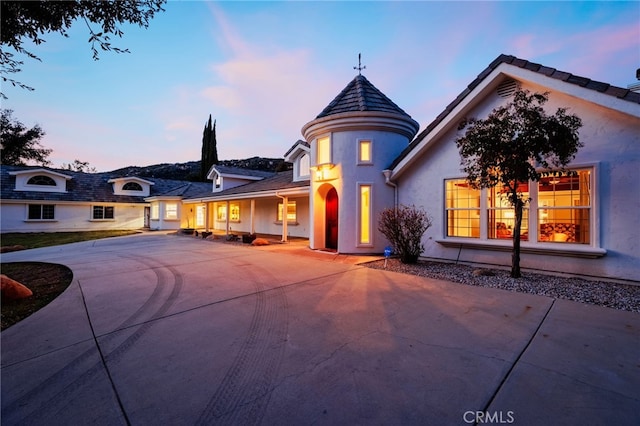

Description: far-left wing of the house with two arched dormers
[0,165,211,232]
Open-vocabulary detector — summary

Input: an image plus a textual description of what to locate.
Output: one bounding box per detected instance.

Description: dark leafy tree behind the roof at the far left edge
[0,109,51,166]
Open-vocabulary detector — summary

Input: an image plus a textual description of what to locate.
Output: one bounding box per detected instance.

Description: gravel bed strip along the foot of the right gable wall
[364,258,640,312]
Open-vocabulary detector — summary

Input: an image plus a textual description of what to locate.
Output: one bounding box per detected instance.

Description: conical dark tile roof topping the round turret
[316,74,411,119]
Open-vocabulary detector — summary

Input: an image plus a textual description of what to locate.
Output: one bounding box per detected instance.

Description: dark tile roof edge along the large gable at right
[389,54,640,172]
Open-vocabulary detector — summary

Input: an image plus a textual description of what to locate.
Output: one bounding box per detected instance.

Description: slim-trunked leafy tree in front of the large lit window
[456,89,583,278]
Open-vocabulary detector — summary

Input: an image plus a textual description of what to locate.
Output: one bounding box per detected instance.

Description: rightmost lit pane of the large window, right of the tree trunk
[537,170,592,244]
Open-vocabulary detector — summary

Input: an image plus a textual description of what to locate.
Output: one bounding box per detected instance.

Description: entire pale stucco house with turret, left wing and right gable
[2,55,640,281]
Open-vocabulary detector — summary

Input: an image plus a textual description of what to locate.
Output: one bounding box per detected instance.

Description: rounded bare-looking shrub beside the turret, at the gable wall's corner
[378,205,432,263]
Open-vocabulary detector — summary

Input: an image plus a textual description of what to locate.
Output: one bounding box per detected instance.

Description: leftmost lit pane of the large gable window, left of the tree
[445,179,480,238]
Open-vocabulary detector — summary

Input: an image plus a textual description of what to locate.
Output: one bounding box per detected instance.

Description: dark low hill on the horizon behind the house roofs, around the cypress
[109,157,292,181]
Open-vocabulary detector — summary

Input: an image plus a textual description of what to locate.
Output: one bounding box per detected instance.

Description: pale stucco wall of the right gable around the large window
[398,85,640,281]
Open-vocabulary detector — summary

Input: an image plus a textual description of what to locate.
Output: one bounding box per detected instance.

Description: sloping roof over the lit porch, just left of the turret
[184,170,310,201]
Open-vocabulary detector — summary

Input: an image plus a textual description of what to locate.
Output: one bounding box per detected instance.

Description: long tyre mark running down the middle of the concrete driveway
[197,258,288,425]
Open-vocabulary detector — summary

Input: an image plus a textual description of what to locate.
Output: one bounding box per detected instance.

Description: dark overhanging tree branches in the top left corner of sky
[0,0,166,98]
